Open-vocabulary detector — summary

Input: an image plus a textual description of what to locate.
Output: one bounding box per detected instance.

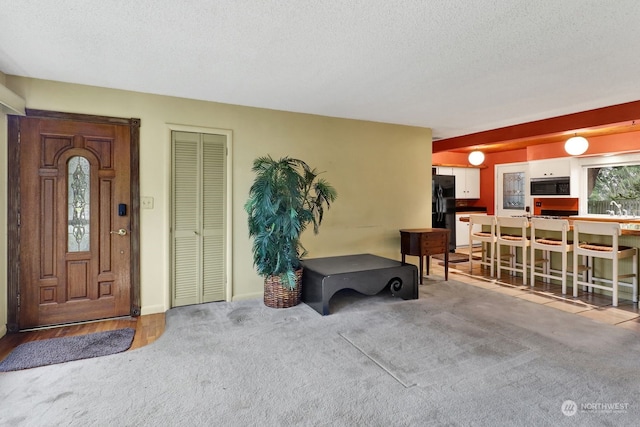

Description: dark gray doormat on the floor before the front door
[0,328,136,372]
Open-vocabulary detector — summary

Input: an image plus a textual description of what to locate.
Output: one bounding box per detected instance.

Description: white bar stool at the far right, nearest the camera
[573,221,638,307]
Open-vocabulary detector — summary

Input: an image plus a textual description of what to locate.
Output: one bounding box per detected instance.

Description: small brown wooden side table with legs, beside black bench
[400,228,451,284]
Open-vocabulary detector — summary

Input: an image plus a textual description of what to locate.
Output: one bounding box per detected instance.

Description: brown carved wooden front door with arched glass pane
[10,111,139,329]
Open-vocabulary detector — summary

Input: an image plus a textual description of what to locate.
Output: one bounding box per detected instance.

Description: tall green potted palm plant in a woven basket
[245,155,337,308]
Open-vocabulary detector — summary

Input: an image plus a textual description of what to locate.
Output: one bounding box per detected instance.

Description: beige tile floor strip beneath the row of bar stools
[428,252,640,332]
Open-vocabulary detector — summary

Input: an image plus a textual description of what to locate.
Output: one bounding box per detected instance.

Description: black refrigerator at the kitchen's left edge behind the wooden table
[431,175,456,252]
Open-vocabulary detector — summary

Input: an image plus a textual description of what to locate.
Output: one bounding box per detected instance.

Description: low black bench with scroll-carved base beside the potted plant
[302,254,418,316]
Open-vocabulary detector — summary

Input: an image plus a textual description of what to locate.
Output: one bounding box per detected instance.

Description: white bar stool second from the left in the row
[496,216,530,285]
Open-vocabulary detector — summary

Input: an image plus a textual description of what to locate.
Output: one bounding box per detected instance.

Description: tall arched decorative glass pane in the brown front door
[67,156,91,252]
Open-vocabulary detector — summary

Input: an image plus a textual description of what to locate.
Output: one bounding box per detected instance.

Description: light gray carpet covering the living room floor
[0,279,640,427]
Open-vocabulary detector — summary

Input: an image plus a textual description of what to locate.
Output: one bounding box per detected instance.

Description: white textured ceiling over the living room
[0,0,640,138]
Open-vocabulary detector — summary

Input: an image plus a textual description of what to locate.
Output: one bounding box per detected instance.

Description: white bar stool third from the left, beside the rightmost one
[530,218,573,295]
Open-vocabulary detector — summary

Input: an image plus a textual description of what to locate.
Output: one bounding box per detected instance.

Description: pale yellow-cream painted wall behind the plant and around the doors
[0,76,431,323]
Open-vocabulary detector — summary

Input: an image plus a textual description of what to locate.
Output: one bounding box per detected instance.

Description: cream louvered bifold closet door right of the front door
[171,131,227,307]
